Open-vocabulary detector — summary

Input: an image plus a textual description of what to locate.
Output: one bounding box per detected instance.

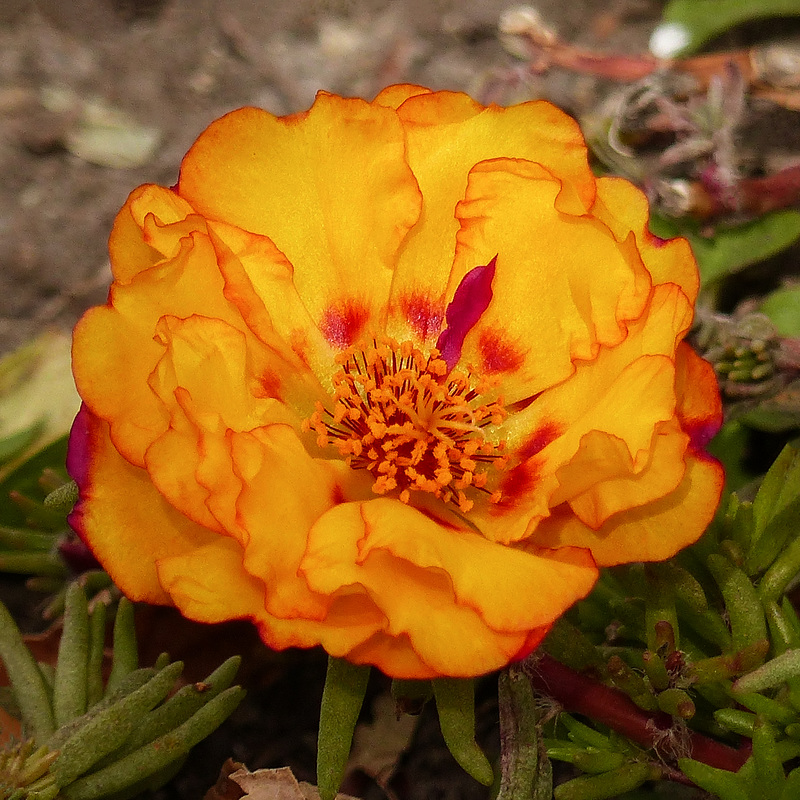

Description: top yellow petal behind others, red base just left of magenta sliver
[388,92,595,339]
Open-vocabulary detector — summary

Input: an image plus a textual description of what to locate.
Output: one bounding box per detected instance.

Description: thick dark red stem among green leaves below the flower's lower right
[525,653,750,779]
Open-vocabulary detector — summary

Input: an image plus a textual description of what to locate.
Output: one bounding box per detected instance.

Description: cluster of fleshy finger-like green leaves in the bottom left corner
[0,584,244,800]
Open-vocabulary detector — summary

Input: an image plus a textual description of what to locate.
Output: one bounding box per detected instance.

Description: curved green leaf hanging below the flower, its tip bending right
[433,678,494,786]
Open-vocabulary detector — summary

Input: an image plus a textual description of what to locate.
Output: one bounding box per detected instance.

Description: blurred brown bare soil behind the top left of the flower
[0,0,662,352]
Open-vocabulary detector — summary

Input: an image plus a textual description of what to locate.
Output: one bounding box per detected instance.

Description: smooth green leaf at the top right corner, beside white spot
[664,0,800,56]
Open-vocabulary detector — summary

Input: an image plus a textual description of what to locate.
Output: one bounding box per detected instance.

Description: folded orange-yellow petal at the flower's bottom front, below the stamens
[301,499,596,677]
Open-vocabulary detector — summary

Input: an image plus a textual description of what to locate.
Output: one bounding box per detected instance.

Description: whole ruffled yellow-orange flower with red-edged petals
[70,86,722,678]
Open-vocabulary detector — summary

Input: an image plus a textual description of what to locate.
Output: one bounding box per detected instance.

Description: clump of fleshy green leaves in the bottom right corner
[533,445,800,800]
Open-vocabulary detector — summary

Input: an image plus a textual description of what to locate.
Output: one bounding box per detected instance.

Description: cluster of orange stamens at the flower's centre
[303,339,508,513]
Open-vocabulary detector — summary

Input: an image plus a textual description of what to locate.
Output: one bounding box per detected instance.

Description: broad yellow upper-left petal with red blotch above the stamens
[178,92,420,349]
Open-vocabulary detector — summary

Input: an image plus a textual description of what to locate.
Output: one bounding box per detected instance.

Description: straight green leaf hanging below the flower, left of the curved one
[317,656,370,800]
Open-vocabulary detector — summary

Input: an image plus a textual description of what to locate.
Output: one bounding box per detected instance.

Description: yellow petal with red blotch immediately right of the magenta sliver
[448,159,650,404]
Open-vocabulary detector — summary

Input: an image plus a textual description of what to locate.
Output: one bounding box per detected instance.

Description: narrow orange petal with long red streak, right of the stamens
[470,284,692,542]
